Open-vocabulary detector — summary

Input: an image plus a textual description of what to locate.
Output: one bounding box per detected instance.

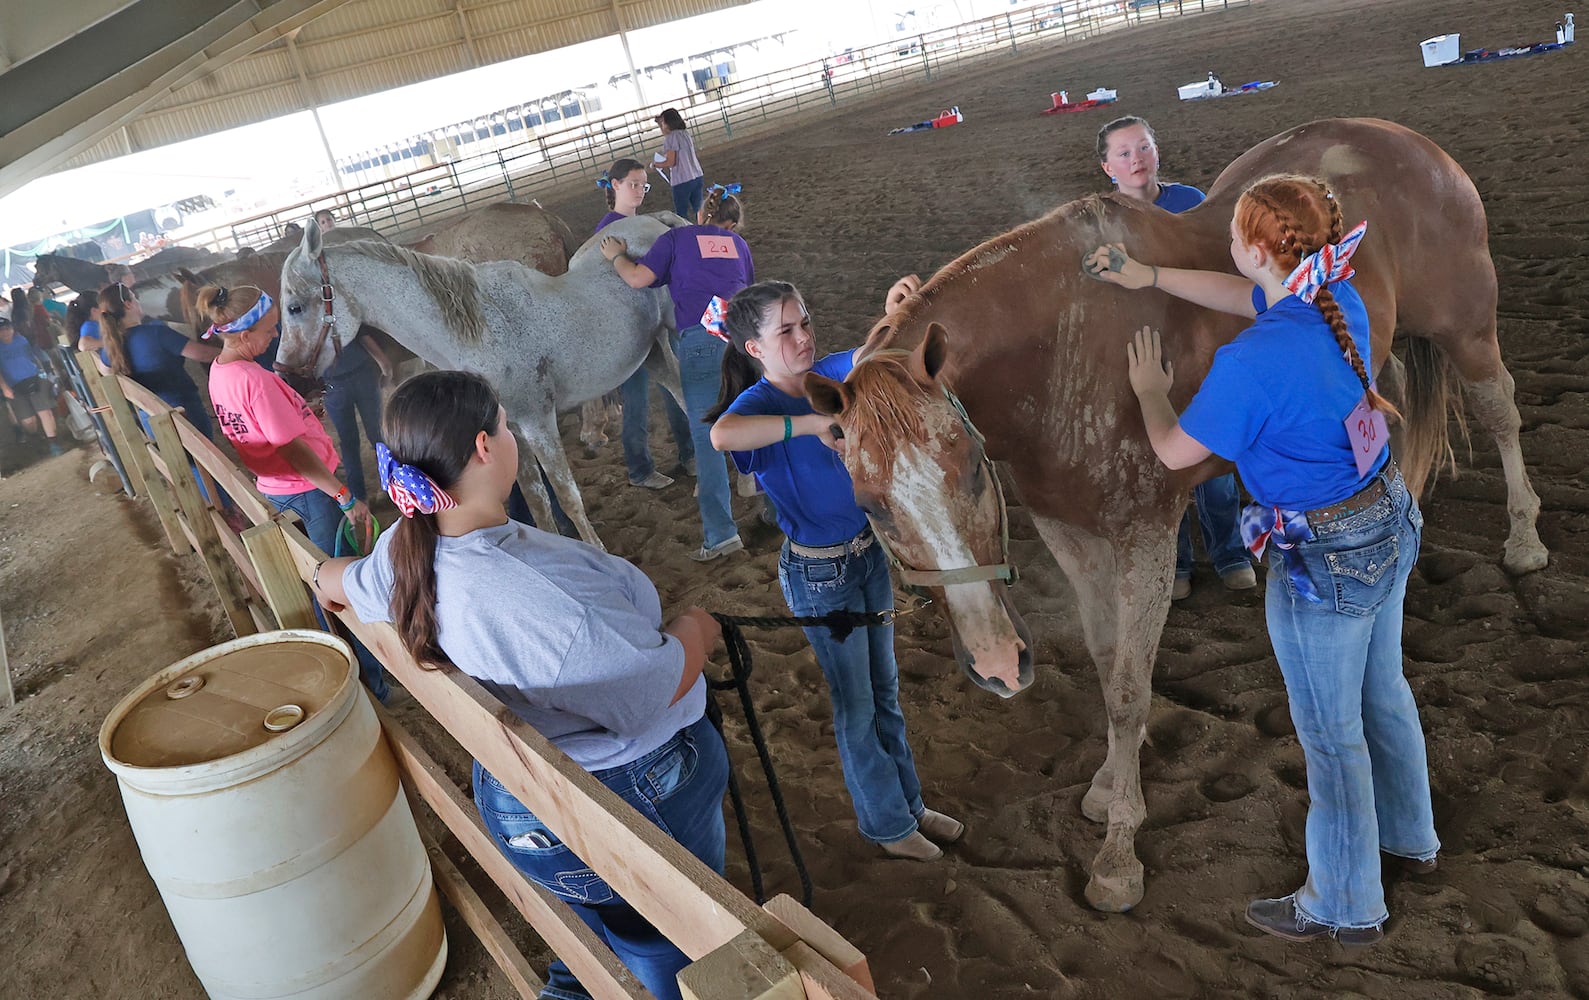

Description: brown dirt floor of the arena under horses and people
[0,0,1589,1000]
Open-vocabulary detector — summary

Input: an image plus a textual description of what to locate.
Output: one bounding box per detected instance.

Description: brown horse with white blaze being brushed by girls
[806,119,1546,911]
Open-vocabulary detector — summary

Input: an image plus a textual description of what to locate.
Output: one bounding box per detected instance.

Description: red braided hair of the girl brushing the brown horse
[1236,173,1400,417]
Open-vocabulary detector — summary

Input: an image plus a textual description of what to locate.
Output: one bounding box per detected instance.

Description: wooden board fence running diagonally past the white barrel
[76,351,876,1000]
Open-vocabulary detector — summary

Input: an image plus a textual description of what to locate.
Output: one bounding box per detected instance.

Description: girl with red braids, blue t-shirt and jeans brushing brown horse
[1087,176,1440,946]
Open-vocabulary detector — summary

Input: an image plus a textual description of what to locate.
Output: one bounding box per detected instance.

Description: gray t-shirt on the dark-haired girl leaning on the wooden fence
[342,521,706,771]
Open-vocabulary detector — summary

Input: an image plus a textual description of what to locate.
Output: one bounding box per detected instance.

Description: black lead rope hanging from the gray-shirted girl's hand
[706,604,922,908]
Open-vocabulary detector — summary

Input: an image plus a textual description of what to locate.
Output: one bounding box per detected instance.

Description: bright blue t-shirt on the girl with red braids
[1181,281,1389,510]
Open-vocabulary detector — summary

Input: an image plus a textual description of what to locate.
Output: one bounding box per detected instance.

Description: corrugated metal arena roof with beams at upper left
[0,0,748,196]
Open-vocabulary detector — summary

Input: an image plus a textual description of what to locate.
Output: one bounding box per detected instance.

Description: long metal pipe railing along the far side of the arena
[167,0,1252,250]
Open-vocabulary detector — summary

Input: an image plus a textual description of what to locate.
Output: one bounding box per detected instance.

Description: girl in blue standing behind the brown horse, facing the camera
[1098,116,1258,601]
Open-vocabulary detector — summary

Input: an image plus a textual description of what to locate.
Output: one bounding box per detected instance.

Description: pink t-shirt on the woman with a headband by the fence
[210,361,337,496]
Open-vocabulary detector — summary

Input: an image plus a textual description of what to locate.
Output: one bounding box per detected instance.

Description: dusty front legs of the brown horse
[1033,515,1174,913]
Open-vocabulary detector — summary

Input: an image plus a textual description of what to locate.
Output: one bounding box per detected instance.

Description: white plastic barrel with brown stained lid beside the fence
[100,630,447,1000]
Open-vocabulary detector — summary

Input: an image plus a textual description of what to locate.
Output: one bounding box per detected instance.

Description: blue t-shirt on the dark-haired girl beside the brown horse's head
[725,351,866,547]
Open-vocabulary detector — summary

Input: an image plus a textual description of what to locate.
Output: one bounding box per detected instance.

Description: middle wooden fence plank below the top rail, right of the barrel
[370,700,655,1000]
